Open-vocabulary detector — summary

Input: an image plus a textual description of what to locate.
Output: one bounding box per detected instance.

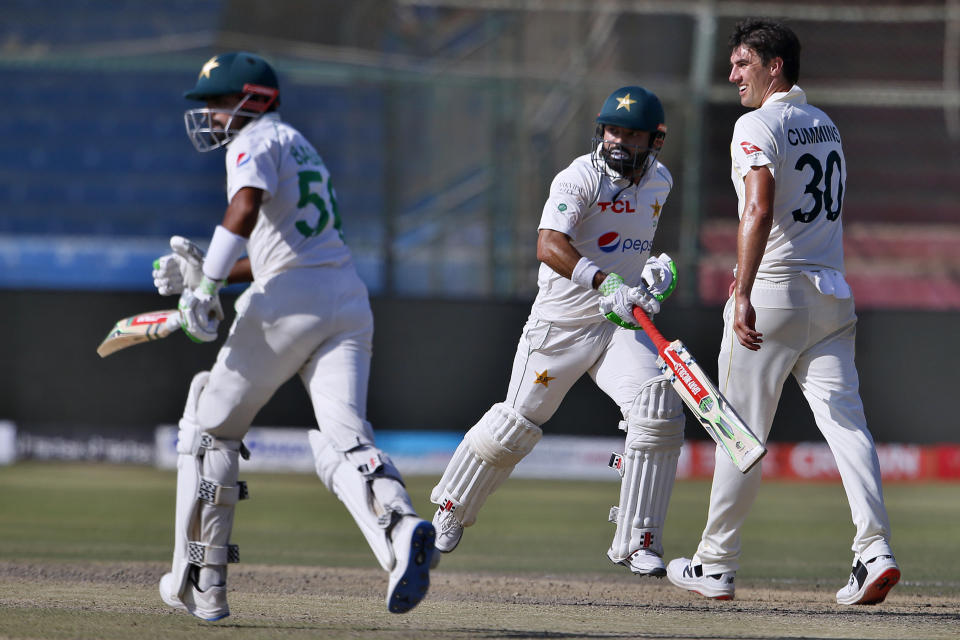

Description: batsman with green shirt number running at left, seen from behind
[154,52,434,620]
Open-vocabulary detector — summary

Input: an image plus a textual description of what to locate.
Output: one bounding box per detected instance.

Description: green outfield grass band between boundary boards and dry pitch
[0,462,960,595]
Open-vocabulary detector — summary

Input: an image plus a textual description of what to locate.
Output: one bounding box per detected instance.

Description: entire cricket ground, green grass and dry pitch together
[0,463,960,640]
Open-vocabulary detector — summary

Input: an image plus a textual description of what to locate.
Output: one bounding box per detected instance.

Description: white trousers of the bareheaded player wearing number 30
[694,275,892,575]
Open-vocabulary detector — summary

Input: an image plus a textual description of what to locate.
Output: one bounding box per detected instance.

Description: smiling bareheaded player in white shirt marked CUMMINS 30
[667,20,900,605]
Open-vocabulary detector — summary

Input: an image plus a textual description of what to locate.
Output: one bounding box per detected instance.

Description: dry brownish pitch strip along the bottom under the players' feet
[0,562,960,640]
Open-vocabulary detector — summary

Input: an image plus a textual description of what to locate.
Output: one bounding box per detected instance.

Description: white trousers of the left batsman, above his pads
[197,264,373,451]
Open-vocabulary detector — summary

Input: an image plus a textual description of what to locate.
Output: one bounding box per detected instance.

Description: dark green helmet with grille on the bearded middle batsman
[592,86,667,182]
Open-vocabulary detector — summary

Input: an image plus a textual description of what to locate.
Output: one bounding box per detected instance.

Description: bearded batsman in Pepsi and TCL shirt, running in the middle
[430,86,684,577]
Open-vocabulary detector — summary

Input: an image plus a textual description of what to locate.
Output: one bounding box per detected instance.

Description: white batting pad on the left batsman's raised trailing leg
[308,429,416,571]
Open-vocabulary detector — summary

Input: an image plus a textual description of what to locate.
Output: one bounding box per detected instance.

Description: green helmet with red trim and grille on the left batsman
[183,51,280,151]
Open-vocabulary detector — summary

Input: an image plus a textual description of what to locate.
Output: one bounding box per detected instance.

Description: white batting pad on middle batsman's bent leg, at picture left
[430,402,543,527]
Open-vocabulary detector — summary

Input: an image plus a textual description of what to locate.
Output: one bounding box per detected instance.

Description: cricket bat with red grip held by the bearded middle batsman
[633,307,767,473]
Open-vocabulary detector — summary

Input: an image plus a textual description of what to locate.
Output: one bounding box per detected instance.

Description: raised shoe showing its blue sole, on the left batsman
[387,516,436,613]
